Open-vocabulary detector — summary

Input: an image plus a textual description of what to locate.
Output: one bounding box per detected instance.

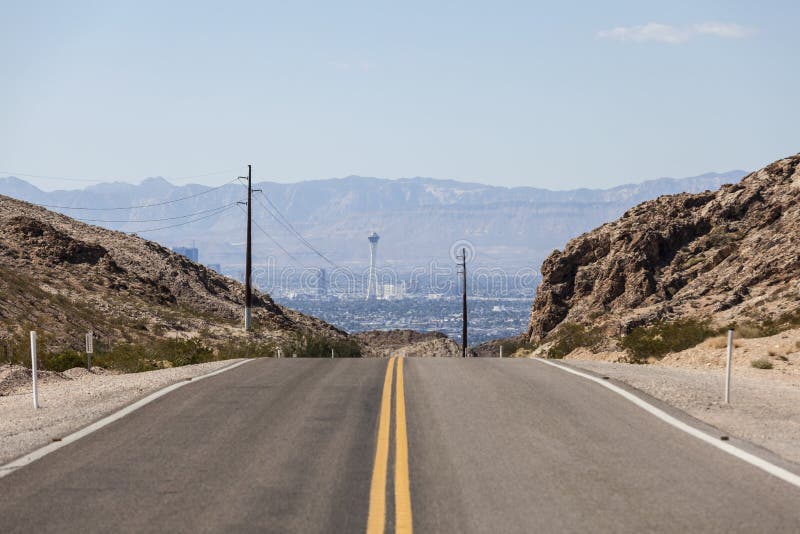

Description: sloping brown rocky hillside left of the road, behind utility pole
[0,196,344,349]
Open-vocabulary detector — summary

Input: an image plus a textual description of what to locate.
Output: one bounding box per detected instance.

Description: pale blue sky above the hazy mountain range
[0,0,800,189]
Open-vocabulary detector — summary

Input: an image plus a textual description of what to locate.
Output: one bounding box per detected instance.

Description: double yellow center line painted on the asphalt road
[367,358,413,534]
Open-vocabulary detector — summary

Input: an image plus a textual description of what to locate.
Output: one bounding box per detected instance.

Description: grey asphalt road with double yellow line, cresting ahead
[0,358,800,533]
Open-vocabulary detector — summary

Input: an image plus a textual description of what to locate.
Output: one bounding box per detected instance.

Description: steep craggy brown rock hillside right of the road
[528,155,800,341]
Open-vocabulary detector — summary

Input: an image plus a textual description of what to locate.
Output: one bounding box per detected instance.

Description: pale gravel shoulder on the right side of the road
[565,358,800,464]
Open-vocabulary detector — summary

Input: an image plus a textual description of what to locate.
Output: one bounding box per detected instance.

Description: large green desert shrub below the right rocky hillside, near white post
[620,319,718,363]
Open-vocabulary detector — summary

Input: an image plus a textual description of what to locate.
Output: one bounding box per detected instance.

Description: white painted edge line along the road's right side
[532,358,800,488]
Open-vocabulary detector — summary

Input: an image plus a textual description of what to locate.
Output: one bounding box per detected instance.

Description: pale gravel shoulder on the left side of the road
[0,360,244,464]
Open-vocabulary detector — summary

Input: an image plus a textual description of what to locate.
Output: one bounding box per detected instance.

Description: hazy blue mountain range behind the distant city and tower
[0,171,745,269]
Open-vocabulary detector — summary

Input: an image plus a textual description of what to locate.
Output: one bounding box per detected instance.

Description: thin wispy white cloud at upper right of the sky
[597,22,754,44]
